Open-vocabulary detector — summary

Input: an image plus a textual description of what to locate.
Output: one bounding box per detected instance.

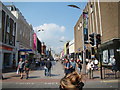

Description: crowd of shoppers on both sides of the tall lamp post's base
[62,58,98,77]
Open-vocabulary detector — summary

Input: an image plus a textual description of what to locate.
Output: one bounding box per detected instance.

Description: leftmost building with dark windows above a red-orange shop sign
[0,2,17,69]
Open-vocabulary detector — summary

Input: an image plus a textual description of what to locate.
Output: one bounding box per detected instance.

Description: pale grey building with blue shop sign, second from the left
[6,5,34,62]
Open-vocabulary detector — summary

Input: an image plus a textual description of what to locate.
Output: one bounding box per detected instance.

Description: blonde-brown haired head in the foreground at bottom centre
[59,72,84,90]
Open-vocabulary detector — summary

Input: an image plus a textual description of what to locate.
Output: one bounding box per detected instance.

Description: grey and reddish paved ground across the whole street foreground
[2,62,119,90]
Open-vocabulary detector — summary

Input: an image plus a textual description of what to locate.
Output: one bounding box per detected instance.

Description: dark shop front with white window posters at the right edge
[99,39,120,70]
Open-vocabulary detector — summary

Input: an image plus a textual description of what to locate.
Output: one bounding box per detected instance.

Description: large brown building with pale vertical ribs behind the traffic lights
[74,2,120,67]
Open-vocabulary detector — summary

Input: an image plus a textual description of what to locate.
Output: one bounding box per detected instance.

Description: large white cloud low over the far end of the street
[34,23,66,52]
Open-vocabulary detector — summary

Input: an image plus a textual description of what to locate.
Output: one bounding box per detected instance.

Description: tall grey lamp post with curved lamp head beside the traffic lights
[68,5,86,74]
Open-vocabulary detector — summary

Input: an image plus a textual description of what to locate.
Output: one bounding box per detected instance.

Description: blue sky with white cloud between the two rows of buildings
[4,2,87,53]
